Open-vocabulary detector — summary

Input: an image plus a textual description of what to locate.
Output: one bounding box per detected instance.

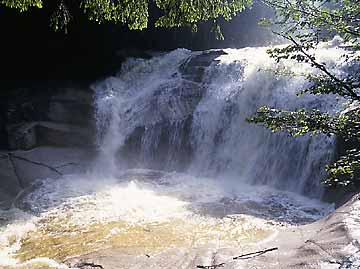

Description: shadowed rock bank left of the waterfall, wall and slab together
[0,85,95,209]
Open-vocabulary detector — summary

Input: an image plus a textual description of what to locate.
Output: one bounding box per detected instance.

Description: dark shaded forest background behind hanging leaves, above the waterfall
[0,1,270,86]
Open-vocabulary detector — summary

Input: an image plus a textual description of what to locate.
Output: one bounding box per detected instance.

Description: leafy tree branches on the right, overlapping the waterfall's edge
[248,0,360,186]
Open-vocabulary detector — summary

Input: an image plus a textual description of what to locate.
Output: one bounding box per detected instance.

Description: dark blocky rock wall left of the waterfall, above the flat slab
[2,87,94,150]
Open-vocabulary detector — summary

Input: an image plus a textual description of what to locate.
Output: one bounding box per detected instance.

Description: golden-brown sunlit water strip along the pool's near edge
[15,218,272,262]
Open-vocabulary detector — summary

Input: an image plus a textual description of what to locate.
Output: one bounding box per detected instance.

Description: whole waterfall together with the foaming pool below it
[0,40,346,268]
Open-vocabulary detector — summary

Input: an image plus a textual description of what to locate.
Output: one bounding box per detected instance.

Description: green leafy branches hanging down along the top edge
[0,0,252,33]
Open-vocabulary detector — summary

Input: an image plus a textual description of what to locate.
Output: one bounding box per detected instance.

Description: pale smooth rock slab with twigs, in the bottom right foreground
[66,195,360,269]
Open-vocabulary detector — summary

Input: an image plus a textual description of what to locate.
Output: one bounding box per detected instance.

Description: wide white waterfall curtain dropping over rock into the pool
[94,44,344,197]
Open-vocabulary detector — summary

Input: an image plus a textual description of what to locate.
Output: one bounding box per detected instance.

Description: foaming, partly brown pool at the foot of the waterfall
[0,170,332,268]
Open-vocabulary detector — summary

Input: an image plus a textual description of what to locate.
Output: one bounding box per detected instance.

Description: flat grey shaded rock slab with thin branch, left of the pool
[0,147,94,209]
